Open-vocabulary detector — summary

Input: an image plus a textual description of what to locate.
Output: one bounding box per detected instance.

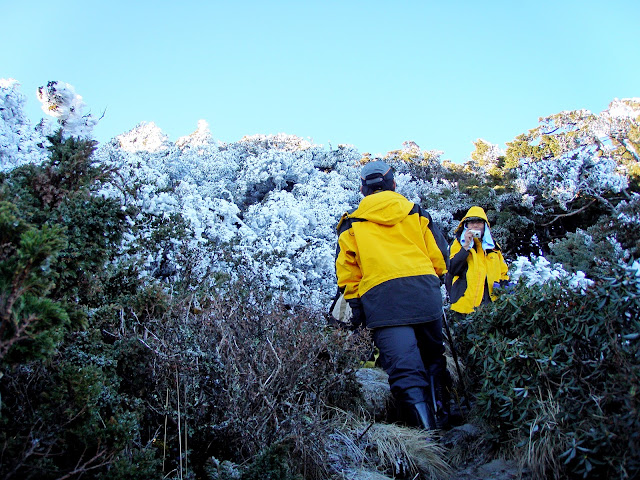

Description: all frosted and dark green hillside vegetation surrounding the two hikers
[0,80,640,480]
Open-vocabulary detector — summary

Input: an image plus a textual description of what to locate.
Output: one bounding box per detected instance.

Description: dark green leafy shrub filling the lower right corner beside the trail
[456,268,640,478]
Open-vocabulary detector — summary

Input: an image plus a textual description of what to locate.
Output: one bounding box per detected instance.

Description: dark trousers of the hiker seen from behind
[373,319,446,405]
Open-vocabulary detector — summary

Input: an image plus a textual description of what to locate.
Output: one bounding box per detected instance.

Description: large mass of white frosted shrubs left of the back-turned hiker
[96,122,368,306]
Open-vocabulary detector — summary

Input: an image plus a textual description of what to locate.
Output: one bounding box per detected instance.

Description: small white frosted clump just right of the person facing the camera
[509,256,593,294]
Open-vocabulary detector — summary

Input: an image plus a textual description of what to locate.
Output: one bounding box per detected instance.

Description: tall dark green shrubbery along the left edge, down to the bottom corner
[0,132,157,479]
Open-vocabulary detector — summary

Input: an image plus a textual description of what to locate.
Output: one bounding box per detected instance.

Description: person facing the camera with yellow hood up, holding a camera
[447,207,509,314]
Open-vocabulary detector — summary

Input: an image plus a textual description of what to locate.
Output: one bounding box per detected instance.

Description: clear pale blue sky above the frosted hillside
[0,0,640,162]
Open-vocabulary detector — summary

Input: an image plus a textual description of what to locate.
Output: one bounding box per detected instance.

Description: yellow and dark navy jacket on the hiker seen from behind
[336,190,449,328]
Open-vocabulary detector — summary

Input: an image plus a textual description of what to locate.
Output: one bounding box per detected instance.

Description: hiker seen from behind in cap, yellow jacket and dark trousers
[336,161,449,429]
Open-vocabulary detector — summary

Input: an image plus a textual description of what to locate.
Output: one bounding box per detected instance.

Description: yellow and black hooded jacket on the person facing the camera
[448,207,509,313]
